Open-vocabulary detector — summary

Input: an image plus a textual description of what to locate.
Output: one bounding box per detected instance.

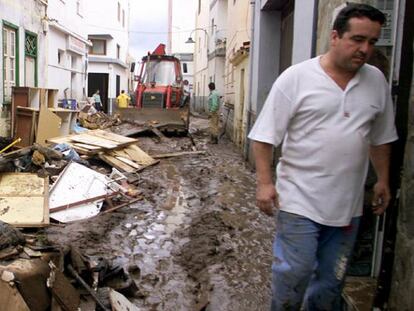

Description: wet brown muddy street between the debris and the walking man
[46,118,275,311]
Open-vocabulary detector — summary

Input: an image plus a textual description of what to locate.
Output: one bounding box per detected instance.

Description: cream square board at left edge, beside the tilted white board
[0,173,49,227]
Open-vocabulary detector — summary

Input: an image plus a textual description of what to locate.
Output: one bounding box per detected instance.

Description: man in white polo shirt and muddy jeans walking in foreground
[249,4,397,310]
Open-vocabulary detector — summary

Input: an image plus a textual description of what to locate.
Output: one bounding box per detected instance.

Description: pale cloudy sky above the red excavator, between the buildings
[129,0,197,60]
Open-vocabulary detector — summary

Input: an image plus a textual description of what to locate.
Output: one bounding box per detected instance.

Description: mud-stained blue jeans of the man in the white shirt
[271,211,360,311]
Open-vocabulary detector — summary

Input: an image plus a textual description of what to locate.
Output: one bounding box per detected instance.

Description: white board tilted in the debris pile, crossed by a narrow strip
[49,162,112,223]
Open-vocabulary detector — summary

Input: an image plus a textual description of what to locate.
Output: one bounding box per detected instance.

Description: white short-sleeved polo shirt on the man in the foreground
[249,57,397,226]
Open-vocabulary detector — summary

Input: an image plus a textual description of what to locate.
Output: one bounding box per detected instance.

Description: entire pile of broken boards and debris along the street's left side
[0,130,159,311]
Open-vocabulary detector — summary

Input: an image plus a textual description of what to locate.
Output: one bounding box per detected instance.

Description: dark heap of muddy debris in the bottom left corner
[0,221,140,311]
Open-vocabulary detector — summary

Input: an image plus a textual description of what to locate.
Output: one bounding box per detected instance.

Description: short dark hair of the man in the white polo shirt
[333,3,386,37]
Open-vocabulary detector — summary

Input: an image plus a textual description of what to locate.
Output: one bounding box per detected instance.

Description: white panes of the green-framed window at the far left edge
[3,27,16,103]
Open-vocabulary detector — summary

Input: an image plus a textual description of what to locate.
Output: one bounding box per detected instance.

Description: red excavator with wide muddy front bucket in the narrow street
[118,44,189,131]
